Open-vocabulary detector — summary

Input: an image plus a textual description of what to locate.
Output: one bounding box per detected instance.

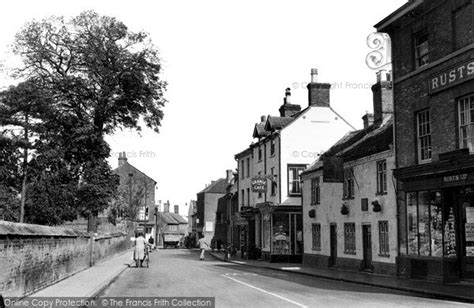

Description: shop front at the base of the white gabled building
[257,202,303,263]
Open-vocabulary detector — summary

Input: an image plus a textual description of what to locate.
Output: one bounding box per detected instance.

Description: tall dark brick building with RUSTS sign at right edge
[375,0,474,281]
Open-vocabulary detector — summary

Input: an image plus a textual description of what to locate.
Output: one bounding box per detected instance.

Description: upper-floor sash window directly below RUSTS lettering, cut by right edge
[459,95,474,153]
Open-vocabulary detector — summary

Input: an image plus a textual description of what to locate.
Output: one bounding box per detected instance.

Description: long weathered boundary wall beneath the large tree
[0,221,131,297]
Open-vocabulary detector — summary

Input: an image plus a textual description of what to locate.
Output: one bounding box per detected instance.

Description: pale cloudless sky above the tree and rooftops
[0,0,407,215]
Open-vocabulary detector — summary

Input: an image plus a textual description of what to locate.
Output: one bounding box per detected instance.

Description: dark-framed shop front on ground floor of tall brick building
[394,152,474,281]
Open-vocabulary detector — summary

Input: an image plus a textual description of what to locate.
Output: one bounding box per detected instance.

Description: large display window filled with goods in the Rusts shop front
[406,191,444,257]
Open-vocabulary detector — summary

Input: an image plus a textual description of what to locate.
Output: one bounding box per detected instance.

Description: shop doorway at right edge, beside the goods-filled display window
[460,198,474,279]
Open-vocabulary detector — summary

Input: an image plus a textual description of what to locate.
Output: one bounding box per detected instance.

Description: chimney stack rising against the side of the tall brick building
[372,70,393,125]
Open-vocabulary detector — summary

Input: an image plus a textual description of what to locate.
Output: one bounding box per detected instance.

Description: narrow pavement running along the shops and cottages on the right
[209,252,474,303]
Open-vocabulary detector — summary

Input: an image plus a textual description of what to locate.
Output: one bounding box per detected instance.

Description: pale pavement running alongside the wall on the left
[28,250,135,299]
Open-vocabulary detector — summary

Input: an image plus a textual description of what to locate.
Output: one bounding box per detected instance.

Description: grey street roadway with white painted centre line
[99,249,473,308]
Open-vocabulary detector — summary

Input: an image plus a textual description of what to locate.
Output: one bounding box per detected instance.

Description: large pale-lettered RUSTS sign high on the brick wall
[429,59,474,94]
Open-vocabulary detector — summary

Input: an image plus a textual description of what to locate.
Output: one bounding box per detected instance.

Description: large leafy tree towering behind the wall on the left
[0,11,166,224]
